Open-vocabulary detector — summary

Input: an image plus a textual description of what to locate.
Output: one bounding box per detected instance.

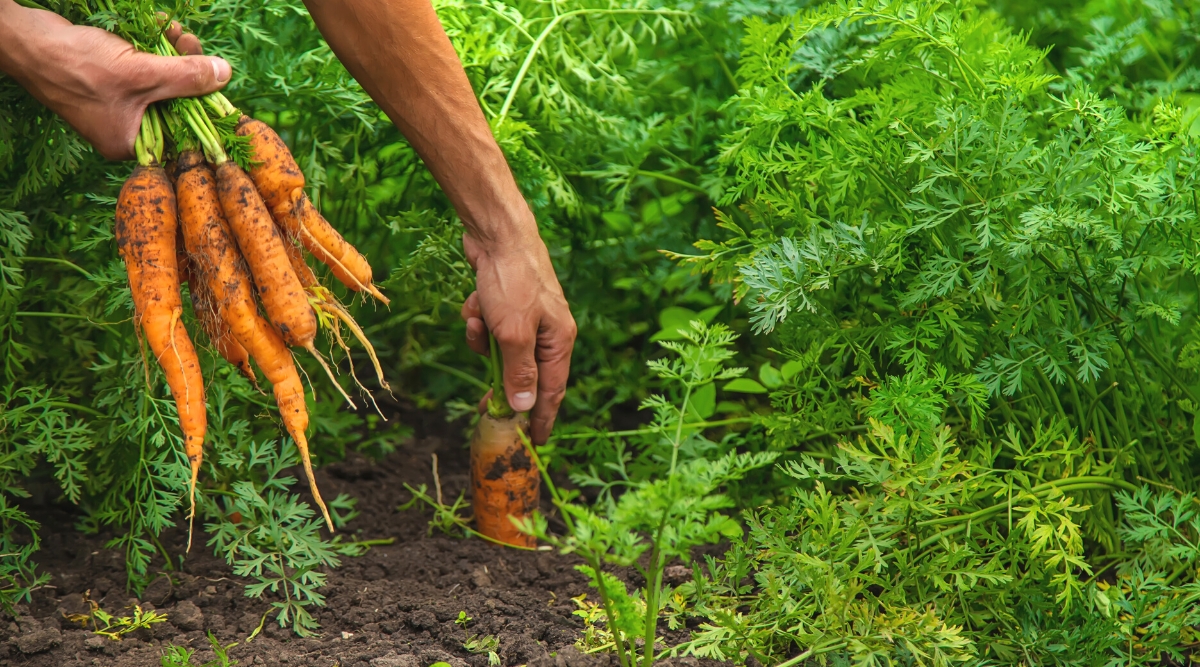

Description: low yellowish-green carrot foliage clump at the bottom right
[683,422,1200,665]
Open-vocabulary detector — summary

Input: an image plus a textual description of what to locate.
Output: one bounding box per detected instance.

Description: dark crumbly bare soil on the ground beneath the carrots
[0,405,707,667]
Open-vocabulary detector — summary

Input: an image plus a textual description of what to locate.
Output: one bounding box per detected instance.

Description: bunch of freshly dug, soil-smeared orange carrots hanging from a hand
[116,32,388,530]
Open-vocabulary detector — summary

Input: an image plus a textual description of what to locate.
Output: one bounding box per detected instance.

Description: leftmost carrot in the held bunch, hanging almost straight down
[115,163,208,518]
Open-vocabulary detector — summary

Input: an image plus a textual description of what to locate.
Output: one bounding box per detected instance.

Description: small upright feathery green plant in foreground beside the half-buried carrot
[523,320,775,667]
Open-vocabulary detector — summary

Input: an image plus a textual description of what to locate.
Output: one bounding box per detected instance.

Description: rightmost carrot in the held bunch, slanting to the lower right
[231,116,389,304]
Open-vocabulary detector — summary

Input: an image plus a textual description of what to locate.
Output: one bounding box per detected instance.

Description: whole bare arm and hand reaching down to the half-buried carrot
[305,0,575,444]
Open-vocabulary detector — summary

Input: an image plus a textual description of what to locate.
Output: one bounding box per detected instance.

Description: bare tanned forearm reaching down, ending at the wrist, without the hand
[306,0,536,247]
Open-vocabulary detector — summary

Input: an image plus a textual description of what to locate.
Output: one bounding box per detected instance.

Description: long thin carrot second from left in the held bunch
[178,151,334,530]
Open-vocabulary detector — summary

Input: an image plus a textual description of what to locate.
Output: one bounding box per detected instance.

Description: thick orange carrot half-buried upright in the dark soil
[470,413,541,547]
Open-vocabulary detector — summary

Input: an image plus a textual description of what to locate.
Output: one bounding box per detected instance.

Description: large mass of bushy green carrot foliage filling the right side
[673,1,1200,666]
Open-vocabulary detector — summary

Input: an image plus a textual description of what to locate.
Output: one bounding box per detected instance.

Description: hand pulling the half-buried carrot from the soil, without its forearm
[462,227,576,445]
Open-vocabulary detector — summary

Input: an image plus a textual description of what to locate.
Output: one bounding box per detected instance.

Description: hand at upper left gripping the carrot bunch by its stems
[0,0,232,160]
